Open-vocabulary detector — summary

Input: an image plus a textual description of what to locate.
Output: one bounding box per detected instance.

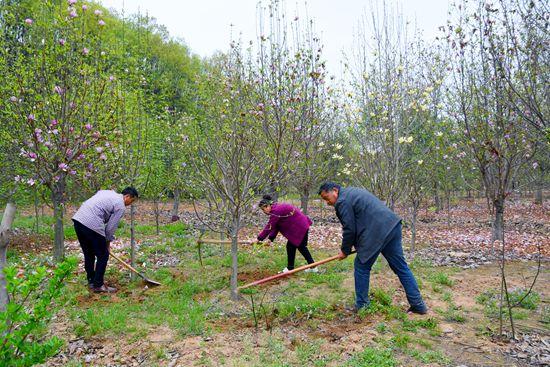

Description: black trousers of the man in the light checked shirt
[73,220,109,288]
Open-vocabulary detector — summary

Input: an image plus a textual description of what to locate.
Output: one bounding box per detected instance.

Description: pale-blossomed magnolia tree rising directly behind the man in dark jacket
[345,4,436,208]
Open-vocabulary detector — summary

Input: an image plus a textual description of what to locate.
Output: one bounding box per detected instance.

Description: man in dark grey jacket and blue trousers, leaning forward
[319,182,428,314]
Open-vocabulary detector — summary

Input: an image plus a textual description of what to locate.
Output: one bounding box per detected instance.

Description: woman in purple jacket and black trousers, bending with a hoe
[258,195,318,273]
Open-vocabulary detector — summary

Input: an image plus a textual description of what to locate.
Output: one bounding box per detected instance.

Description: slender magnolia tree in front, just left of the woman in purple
[191,49,269,299]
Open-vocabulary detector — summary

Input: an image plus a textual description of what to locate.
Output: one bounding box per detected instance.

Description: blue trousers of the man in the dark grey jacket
[354,223,426,310]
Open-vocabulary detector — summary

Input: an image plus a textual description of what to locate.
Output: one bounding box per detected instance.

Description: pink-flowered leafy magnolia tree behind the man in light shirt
[7,0,118,260]
